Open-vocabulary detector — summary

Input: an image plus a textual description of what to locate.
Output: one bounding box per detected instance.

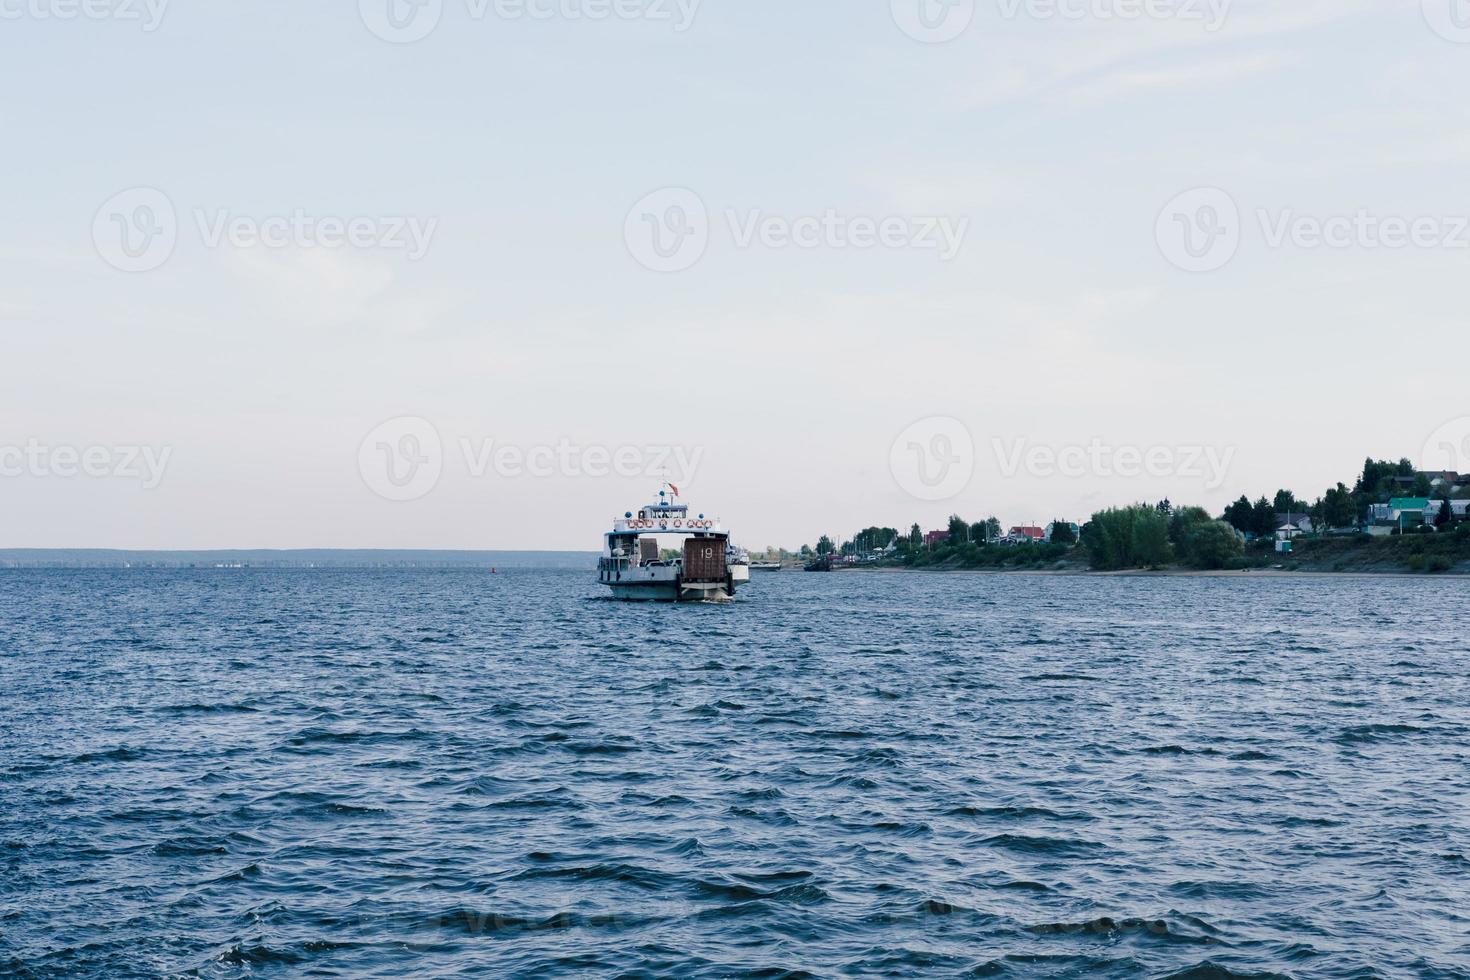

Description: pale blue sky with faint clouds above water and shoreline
[0,0,1470,550]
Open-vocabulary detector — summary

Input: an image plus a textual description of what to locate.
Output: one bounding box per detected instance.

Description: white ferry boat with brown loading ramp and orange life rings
[597,483,750,602]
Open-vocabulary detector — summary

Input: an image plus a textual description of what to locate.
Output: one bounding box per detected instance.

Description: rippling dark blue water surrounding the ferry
[0,570,1470,979]
